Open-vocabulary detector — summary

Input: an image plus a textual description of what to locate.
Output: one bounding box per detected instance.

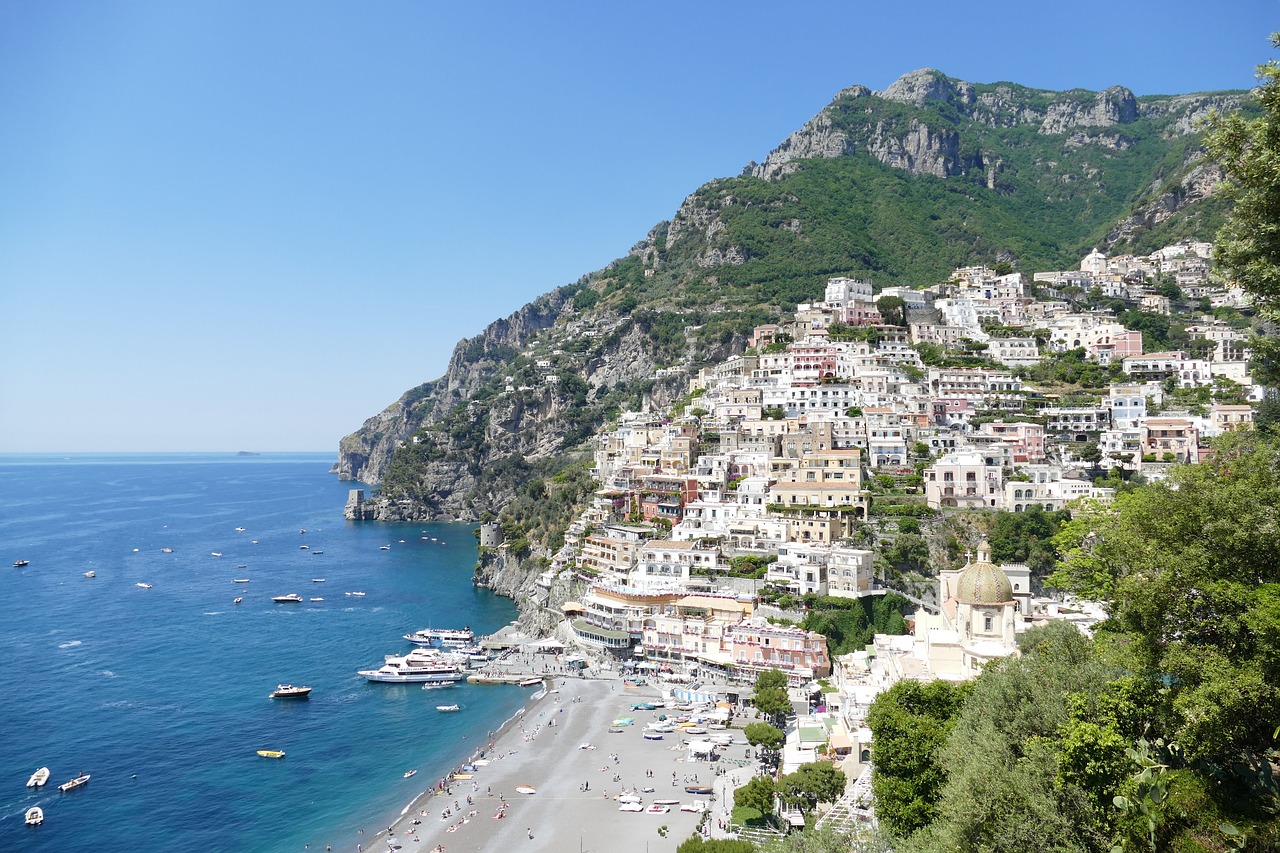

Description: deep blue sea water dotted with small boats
[0,453,529,852]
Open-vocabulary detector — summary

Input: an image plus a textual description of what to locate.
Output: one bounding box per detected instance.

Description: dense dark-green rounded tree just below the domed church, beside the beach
[867,681,969,834]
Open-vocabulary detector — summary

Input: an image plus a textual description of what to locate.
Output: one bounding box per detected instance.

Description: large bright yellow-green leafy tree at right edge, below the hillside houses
[1051,432,1280,763]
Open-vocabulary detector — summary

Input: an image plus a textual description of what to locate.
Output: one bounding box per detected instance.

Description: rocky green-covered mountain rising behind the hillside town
[334,69,1248,527]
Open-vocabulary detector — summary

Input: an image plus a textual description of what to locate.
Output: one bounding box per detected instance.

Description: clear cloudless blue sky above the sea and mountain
[0,0,1280,452]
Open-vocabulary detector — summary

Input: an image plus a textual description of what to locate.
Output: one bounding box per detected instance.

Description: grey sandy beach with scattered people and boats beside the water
[343,676,745,853]
